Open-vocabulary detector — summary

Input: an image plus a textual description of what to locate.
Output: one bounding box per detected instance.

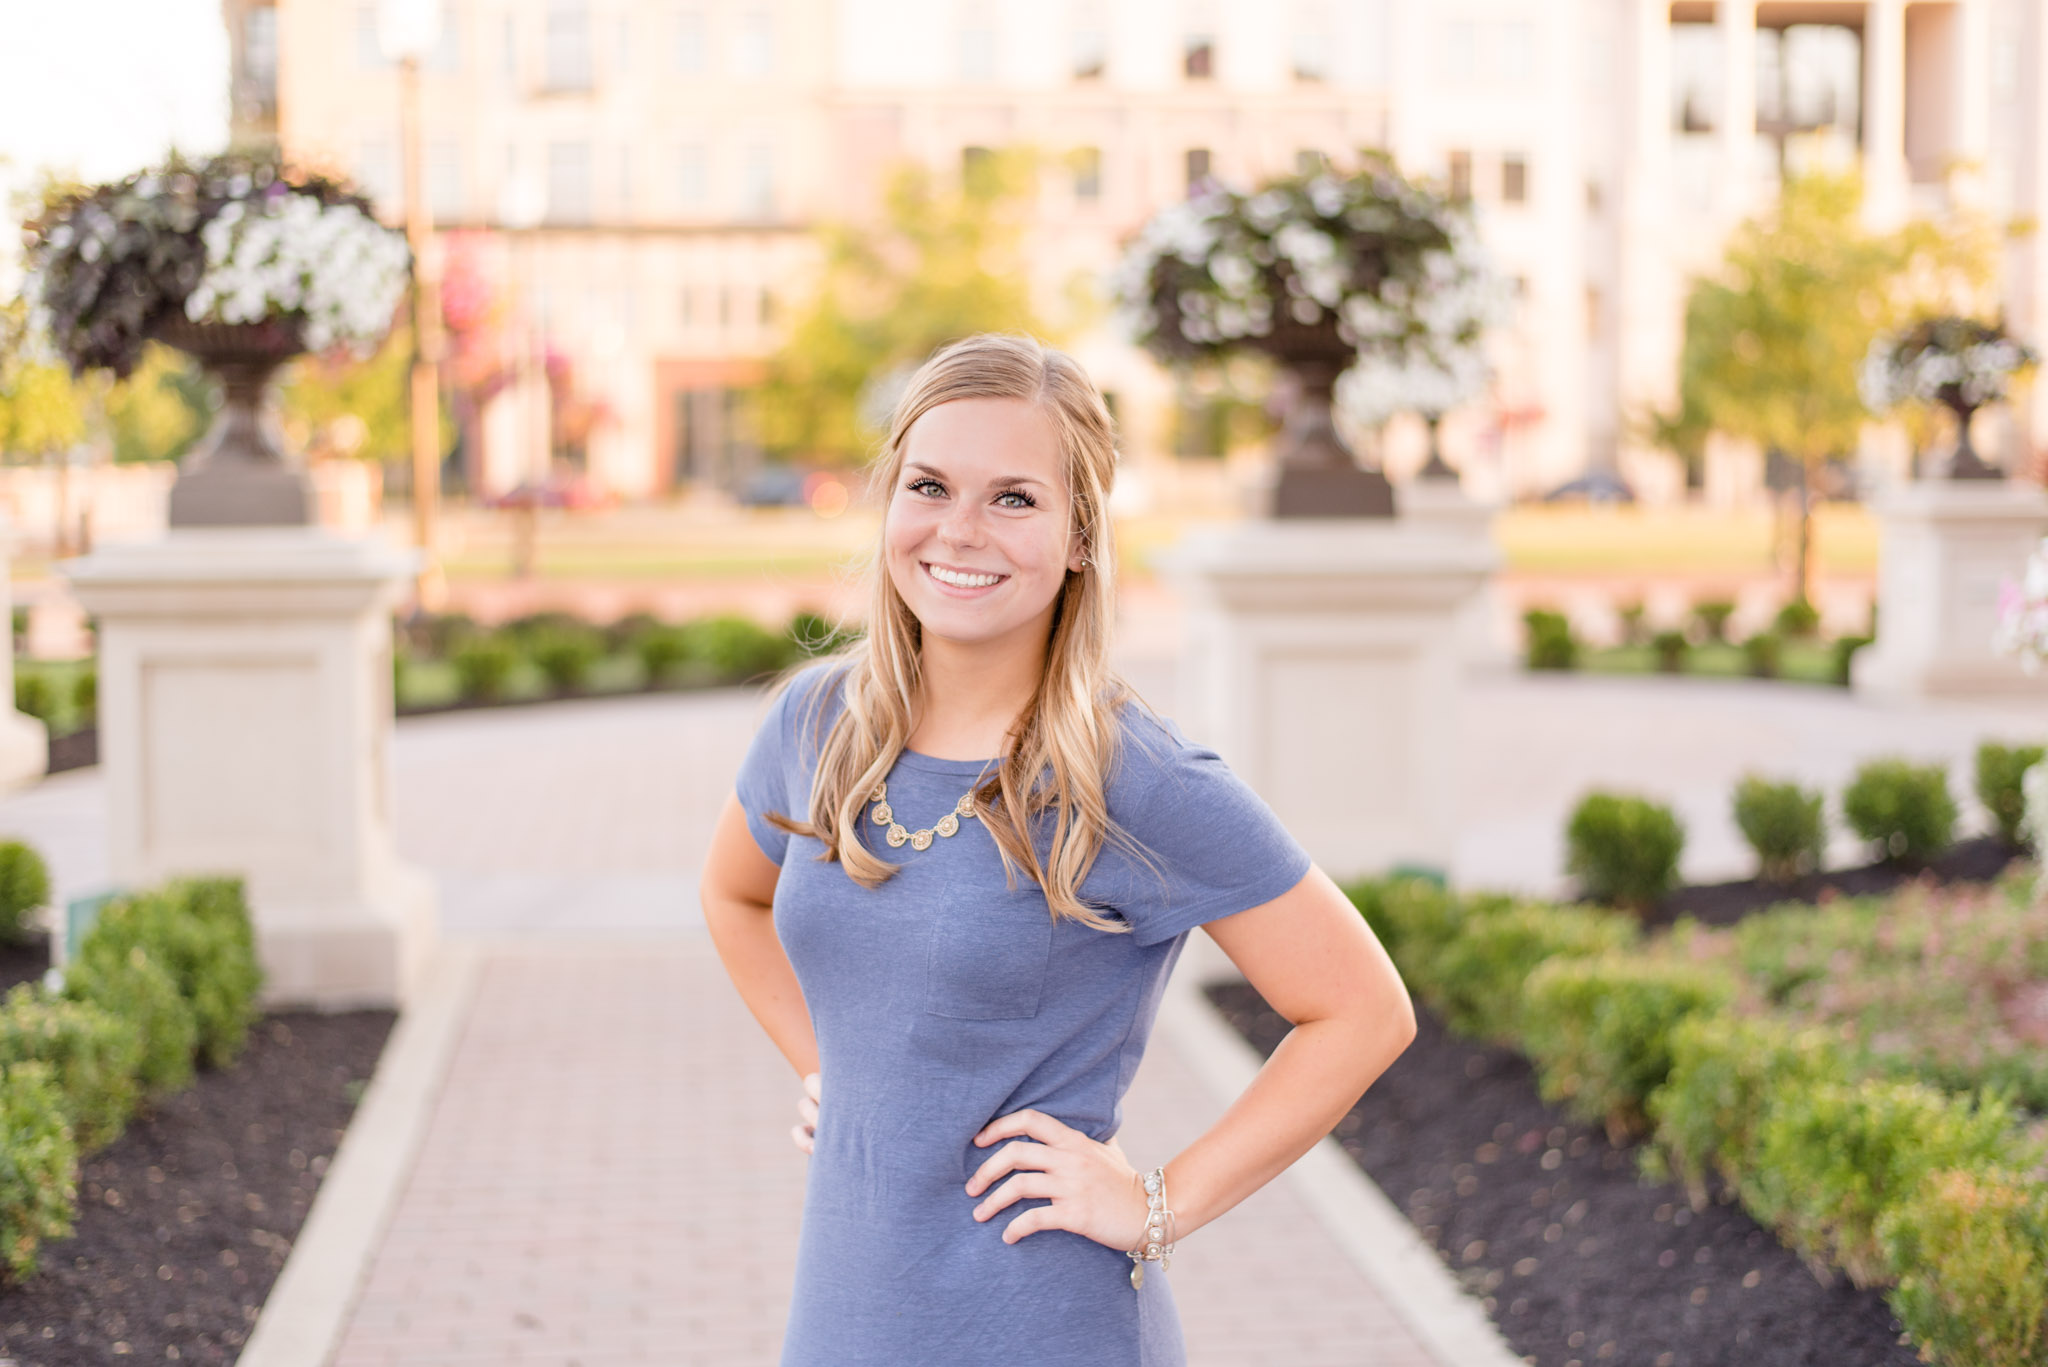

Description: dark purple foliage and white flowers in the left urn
[25,154,412,375]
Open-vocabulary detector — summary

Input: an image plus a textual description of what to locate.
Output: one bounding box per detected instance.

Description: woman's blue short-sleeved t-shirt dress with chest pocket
[737,662,1309,1367]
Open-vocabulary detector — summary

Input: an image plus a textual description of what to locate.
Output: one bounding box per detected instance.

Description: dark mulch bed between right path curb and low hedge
[1206,982,1919,1367]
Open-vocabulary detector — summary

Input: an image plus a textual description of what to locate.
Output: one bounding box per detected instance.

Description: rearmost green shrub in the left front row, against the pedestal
[86,879,262,1068]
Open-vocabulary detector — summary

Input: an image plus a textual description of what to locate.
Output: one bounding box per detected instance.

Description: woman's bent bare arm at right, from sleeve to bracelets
[1165,867,1415,1236]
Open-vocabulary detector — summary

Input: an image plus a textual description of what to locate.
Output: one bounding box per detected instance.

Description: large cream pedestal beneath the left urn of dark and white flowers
[59,527,434,1008]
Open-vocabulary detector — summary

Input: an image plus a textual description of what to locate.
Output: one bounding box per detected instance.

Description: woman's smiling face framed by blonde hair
[883,398,1081,646]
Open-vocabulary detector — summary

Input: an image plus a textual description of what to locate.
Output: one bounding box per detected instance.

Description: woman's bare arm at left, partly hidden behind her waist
[698,797,817,1076]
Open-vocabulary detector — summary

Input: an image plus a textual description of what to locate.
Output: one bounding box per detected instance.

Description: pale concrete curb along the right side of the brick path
[1159,937,1524,1367]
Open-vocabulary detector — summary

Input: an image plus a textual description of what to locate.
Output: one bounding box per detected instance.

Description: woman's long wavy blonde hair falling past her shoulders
[768,332,1135,933]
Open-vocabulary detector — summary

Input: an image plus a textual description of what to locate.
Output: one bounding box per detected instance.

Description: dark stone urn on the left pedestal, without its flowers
[156,318,313,527]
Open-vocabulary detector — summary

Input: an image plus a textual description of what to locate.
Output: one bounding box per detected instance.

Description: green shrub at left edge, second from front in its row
[0,984,143,1154]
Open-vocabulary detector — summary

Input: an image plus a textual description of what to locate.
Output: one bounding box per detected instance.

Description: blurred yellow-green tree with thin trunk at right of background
[1663,172,1993,603]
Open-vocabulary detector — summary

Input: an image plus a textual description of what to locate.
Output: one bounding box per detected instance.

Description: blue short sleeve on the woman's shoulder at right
[1083,713,1311,945]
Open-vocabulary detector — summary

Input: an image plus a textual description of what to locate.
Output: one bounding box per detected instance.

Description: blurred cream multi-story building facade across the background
[239,0,2048,494]
